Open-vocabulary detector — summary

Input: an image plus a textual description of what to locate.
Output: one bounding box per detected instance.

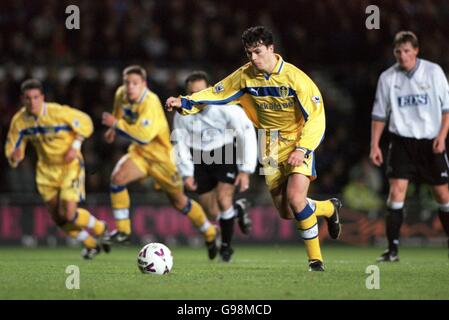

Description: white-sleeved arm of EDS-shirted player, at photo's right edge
[433,67,449,153]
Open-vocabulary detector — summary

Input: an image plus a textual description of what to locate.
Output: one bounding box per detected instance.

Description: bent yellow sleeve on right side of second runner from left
[115,97,166,144]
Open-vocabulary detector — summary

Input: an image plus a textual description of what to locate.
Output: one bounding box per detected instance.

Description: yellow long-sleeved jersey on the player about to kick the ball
[180,54,326,153]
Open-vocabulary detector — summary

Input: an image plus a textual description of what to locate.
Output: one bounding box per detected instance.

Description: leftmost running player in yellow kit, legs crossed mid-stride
[5,79,110,259]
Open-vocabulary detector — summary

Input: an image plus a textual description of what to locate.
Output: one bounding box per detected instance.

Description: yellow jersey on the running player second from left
[113,86,173,162]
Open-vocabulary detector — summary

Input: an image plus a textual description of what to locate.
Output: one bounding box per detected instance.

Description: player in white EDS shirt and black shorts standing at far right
[370,31,449,262]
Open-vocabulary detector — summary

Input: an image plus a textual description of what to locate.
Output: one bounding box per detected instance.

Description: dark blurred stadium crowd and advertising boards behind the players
[0,0,449,246]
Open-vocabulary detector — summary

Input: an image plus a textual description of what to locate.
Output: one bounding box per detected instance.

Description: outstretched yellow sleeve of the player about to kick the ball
[180,67,245,114]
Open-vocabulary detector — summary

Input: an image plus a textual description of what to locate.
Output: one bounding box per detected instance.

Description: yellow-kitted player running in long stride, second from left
[103,66,217,259]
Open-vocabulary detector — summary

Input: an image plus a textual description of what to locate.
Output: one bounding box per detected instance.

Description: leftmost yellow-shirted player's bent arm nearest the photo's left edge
[5,116,27,168]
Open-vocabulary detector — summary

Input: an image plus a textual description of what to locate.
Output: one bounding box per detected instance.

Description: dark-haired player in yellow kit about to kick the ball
[166,26,341,271]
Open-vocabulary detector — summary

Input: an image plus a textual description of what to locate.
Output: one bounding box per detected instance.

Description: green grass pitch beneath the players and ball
[0,245,449,300]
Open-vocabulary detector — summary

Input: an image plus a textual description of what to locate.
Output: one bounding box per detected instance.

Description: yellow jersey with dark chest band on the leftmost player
[5,102,93,167]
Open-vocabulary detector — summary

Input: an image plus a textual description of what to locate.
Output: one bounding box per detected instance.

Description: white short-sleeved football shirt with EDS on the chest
[372,59,449,139]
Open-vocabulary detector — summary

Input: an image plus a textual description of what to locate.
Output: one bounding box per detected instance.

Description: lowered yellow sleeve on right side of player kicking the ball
[295,75,326,155]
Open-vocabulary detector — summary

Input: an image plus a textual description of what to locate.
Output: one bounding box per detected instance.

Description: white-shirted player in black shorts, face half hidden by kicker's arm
[173,71,257,262]
